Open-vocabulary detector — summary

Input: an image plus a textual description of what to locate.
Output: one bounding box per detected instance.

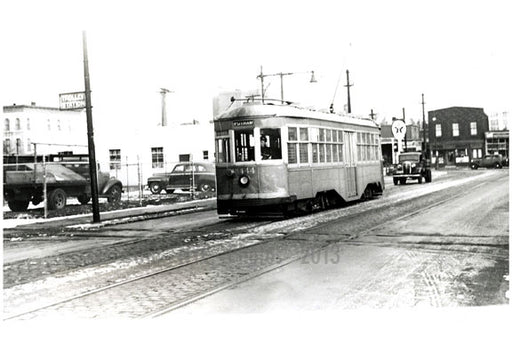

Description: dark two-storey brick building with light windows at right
[428,106,489,166]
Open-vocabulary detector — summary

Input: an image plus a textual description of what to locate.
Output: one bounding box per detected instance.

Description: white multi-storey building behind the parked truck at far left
[3,103,87,155]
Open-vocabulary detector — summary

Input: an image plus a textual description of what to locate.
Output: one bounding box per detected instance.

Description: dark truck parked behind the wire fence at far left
[3,156,123,212]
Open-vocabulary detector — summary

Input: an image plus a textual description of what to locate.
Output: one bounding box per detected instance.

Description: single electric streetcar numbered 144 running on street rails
[214,102,384,216]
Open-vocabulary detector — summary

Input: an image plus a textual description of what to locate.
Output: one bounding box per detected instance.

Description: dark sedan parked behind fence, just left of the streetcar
[165,162,215,193]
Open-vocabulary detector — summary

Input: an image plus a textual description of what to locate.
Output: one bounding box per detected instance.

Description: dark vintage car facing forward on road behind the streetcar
[393,152,432,185]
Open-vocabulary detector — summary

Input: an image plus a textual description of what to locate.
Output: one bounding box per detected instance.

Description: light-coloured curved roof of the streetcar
[215,103,379,127]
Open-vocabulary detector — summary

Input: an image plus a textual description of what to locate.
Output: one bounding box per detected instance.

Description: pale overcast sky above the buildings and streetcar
[0,0,512,128]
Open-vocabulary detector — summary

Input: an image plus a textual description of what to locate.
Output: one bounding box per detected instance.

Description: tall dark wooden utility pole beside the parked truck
[82,31,100,223]
